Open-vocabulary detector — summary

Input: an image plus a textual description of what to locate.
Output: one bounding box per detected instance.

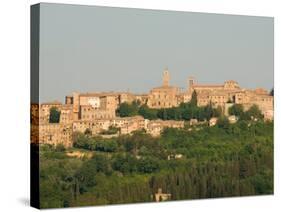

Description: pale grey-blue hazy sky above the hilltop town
[40,3,274,102]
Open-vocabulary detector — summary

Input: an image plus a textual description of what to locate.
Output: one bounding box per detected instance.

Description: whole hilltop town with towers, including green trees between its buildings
[31,68,274,146]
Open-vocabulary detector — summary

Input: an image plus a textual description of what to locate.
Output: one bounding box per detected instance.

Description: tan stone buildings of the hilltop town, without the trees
[31,69,273,147]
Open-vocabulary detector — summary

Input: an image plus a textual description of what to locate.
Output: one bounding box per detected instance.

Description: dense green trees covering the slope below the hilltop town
[40,120,273,208]
